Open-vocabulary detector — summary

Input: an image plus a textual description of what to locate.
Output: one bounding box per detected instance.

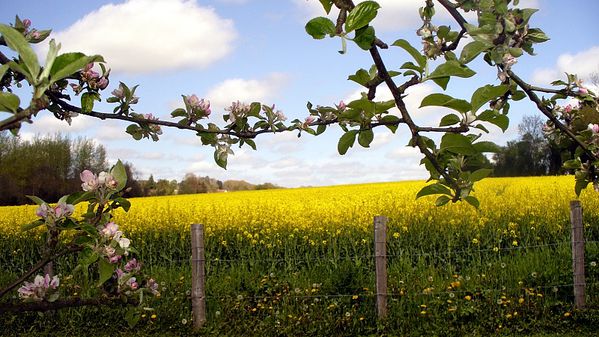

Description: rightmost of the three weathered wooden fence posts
[570,200,586,309]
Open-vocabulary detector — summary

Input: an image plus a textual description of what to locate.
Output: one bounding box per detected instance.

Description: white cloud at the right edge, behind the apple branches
[533,46,599,85]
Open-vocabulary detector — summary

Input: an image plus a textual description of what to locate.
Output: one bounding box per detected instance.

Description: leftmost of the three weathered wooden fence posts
[191,224,206,330]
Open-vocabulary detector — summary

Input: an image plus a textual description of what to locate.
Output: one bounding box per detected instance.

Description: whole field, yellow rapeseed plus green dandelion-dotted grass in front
[0,177,599,336]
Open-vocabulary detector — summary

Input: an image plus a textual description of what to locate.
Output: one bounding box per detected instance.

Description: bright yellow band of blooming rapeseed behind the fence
[0,176,599,239]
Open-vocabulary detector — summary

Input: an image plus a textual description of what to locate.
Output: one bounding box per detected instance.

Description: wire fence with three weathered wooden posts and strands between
[182,207,599,324]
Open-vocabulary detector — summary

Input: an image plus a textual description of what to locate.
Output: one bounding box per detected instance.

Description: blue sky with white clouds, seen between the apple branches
[0,0,599,187]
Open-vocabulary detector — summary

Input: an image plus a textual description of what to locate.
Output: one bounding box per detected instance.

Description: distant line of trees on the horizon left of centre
[0,132,280,205]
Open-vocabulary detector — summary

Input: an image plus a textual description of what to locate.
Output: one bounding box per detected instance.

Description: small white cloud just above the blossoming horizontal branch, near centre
[205,73,289,111]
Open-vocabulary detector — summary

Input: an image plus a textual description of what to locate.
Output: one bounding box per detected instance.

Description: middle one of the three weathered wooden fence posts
[374,216,387,319]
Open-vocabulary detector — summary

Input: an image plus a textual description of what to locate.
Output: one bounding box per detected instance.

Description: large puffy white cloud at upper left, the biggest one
[40,0,237,73]
